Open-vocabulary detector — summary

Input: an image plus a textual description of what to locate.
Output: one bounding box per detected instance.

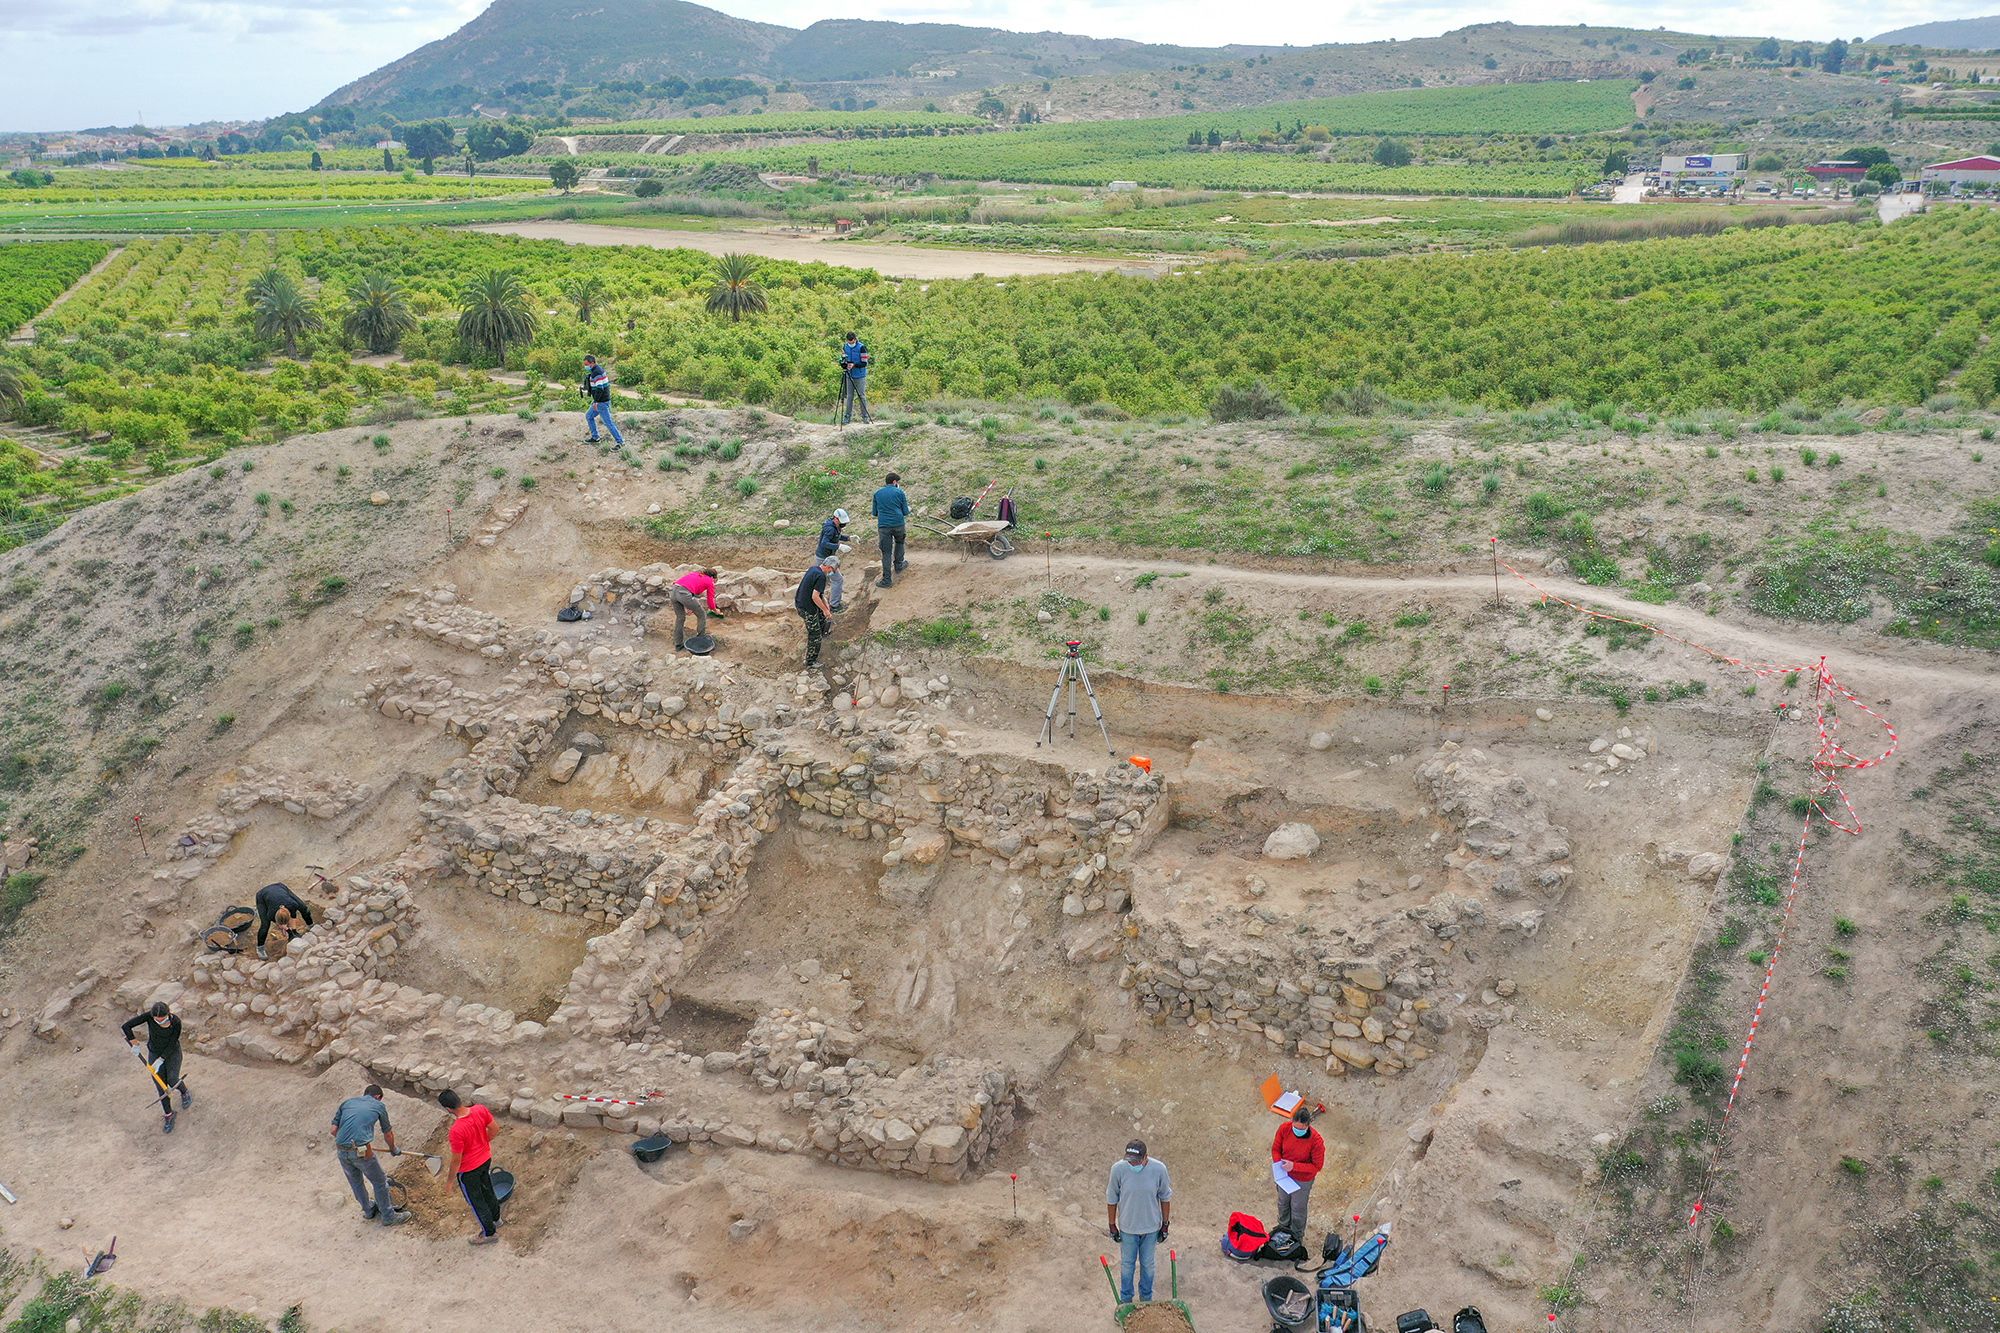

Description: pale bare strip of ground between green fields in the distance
[466,222,1168,278]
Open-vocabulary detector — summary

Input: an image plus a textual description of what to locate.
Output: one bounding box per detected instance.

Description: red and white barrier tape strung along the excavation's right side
[1490,536,1902,1227]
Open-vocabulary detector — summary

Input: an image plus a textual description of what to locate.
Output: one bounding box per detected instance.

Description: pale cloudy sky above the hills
[0,0,1976,130]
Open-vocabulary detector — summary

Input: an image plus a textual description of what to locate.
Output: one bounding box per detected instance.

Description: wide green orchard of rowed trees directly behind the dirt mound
[3,210,2000,452]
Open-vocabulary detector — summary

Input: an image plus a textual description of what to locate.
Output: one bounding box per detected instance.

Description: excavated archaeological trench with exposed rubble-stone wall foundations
[109,548,1764,1320]
